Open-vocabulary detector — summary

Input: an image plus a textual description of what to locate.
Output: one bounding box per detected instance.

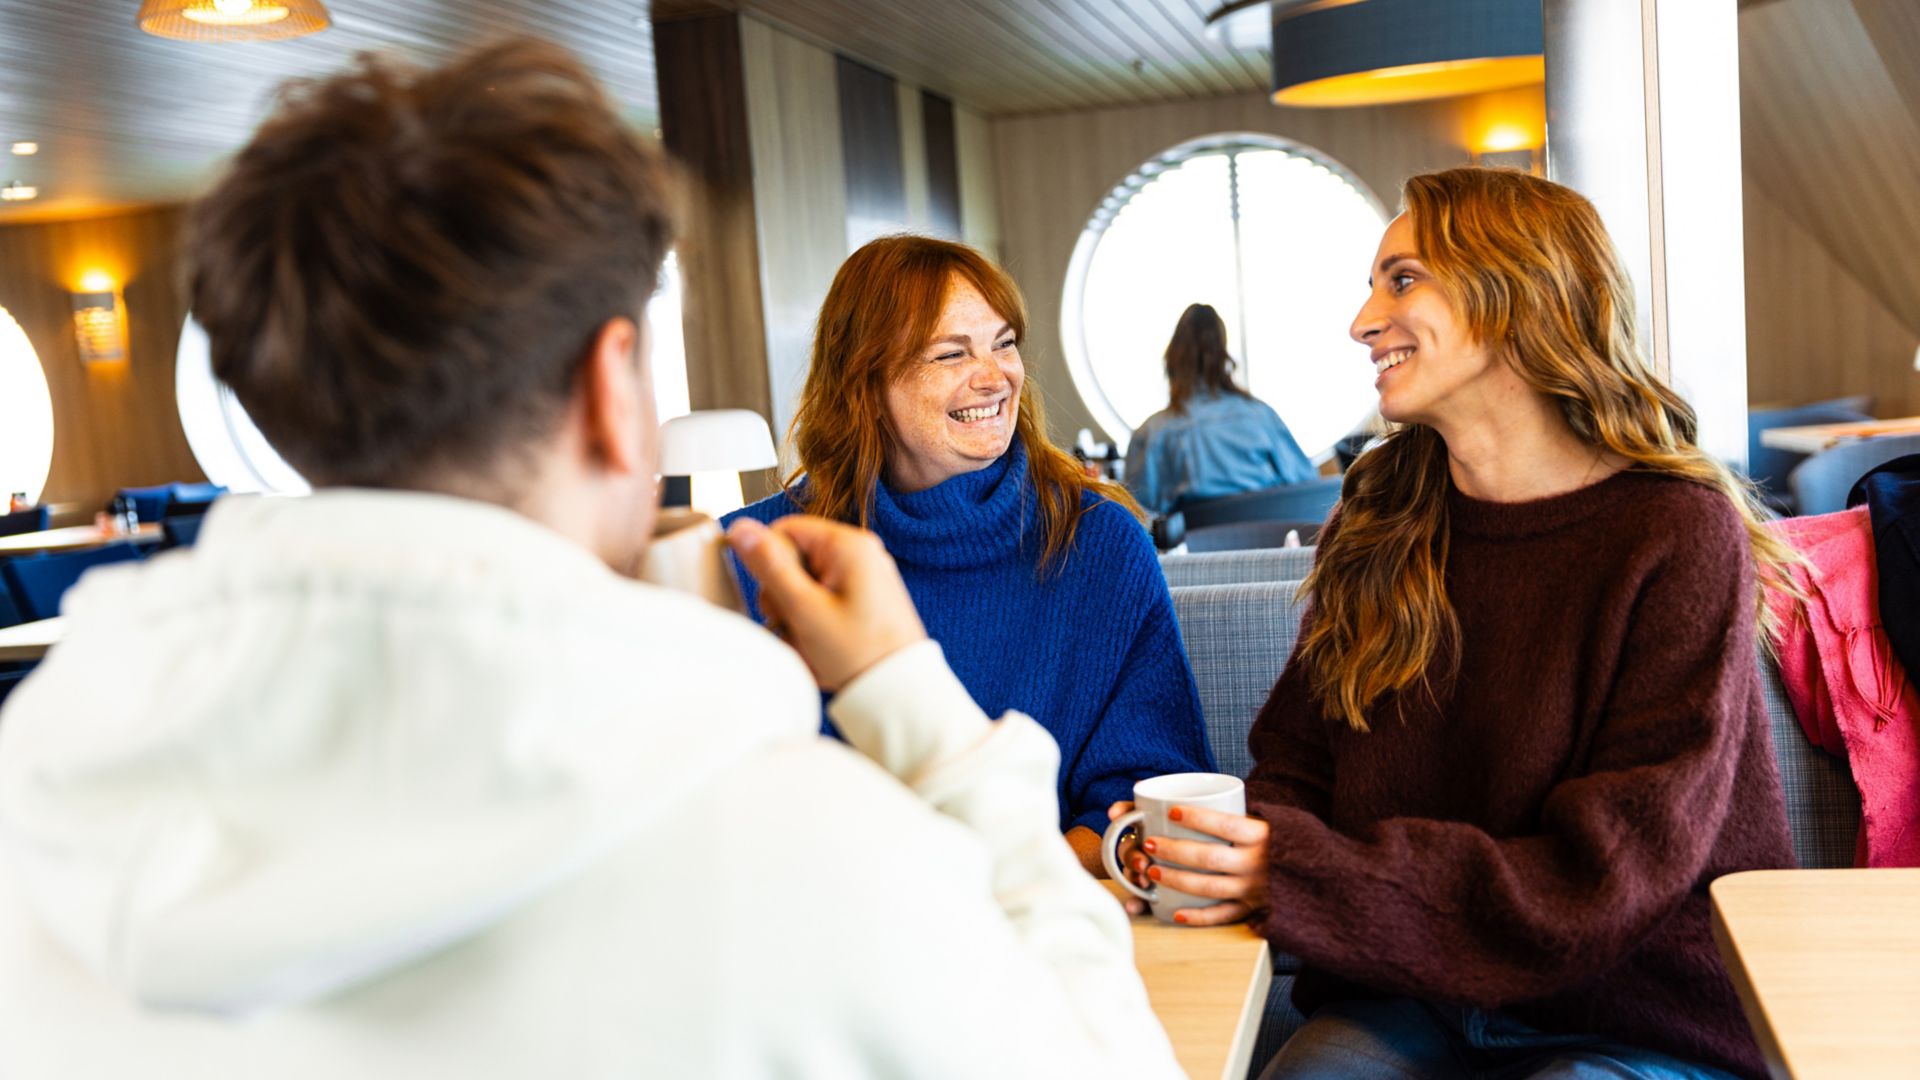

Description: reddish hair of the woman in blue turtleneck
[783,234,1144,571]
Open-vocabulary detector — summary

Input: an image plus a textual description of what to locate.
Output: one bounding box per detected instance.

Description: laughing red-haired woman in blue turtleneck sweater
[721,236,1213,869]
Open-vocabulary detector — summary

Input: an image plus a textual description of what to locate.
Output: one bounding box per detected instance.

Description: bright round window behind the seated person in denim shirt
[1060,135,1386,457]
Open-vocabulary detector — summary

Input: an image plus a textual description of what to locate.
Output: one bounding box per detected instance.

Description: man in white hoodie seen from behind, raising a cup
[0,42,1179,1080]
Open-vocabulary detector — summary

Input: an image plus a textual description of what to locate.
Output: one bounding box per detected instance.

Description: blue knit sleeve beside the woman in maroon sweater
[1060,503,1215,832]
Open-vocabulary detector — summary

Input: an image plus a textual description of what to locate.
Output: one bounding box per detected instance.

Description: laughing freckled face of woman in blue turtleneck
[887,277,1025,492]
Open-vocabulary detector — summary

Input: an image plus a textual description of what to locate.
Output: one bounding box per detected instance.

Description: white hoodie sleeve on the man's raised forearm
[828,642,1183,1076]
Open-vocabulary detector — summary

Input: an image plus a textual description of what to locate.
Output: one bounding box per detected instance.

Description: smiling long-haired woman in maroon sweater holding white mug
[1135,169,1791,1078]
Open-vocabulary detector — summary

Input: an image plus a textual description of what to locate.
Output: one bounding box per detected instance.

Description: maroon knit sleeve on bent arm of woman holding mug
[1250,521,1755,1007]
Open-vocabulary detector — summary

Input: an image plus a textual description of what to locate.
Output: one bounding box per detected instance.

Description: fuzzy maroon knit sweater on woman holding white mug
[1248,473,1793,1078]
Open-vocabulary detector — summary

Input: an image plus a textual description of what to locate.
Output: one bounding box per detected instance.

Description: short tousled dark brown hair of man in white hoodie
[188,40,678,486]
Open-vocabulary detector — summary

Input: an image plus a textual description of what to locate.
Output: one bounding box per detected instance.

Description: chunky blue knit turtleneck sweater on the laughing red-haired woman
[728,440,1213,832]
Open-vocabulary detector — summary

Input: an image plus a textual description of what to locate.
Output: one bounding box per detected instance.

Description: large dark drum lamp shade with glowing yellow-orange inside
[1273,0,1546,106]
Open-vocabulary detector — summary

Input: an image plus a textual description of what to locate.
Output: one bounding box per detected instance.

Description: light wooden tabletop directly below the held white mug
[1106,882,1273,1080]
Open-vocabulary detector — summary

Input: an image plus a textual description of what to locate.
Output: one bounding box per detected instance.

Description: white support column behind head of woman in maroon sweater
[1542,0,1747,457]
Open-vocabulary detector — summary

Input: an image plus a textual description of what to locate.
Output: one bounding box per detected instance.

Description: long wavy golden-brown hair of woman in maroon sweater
[1300,169,1799,730]
